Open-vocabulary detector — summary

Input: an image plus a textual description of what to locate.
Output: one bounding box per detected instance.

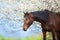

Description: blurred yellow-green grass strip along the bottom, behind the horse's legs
[0,35,52,40]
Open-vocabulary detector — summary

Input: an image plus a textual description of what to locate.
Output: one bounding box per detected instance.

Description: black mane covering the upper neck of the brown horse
[31,10,50,21]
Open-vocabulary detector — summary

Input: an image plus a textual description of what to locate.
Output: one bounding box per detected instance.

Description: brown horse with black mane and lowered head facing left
[23,10,60,40]
